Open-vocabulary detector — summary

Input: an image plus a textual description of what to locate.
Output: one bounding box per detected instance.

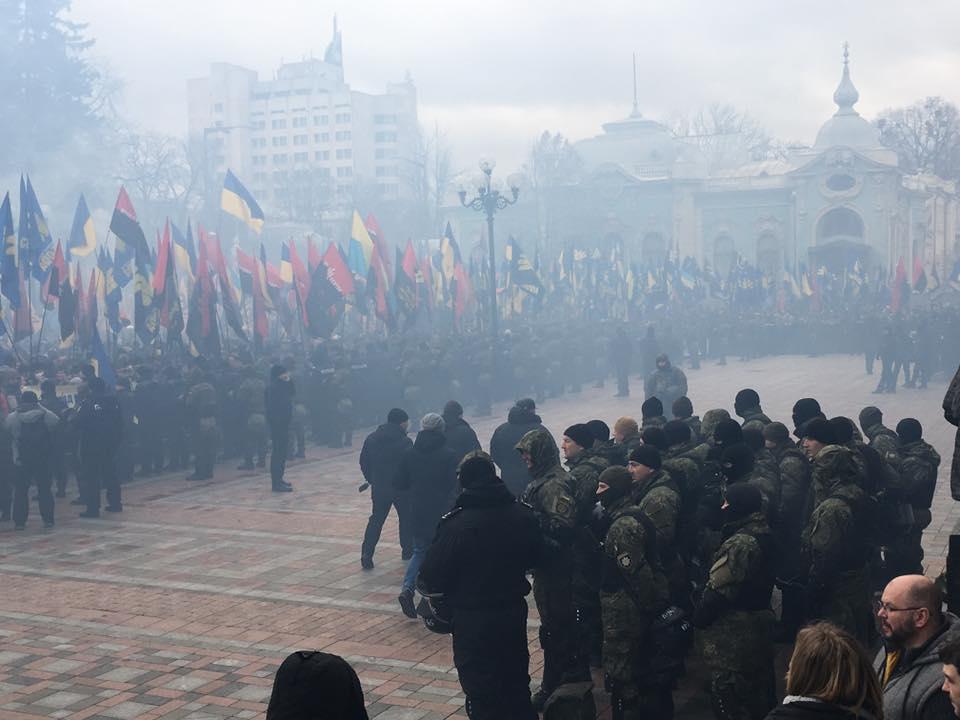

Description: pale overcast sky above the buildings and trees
[72,0,960,171]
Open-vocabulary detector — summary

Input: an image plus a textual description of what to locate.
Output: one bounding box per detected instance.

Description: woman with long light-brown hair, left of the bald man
[767,623,883,720]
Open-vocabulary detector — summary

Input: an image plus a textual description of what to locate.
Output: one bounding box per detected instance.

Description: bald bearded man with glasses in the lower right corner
[874,575,960,720]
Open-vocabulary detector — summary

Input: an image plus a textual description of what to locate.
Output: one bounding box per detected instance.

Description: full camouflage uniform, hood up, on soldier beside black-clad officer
[516,429,590,700]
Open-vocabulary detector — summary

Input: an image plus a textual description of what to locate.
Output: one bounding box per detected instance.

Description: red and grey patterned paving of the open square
[0,357,957,720]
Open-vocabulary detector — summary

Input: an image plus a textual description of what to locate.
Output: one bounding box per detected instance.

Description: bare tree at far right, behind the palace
[876,97,960,180]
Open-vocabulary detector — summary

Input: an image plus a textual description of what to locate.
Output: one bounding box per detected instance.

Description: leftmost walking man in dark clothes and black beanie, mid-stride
[360,408,413,570]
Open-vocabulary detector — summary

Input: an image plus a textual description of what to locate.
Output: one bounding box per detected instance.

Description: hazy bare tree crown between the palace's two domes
[669,103,786,170]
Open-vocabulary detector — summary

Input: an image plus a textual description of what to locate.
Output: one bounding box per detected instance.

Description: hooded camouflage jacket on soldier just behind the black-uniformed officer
[516,429,577,549]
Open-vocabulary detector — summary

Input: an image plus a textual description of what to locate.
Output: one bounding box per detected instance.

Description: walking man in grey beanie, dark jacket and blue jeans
[393,413,460,618]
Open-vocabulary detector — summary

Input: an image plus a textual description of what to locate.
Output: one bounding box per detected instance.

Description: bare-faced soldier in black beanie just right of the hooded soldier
[561,423,610,667]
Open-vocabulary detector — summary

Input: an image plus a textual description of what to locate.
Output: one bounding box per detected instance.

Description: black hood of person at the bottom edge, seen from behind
[267,650,368,720]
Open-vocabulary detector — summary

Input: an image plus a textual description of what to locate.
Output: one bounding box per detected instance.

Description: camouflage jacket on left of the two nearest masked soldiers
[600,495,669,613]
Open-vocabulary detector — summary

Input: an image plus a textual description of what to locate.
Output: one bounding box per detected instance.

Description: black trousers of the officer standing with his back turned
[453,598,537,720]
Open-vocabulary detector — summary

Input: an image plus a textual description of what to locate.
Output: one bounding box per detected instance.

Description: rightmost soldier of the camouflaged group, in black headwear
[885,418,940,576]
